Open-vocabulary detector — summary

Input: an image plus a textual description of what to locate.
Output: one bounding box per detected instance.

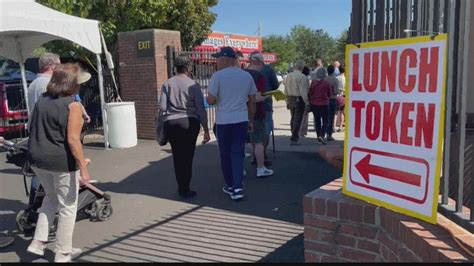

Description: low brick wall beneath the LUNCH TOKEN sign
[303,179,474,262]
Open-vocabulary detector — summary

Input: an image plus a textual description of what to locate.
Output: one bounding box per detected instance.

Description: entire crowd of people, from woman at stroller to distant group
[2,47,344,262]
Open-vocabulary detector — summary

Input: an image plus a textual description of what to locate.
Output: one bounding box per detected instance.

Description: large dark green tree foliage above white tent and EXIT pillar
[38,0,218,63]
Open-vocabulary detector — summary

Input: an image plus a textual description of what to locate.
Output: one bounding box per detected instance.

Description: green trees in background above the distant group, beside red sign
[262,25,347,71]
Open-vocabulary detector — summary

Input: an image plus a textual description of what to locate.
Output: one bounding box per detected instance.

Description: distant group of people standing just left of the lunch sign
[284,59,345,145]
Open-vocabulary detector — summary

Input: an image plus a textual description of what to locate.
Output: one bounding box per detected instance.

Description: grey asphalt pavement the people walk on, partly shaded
[0,102,342,262]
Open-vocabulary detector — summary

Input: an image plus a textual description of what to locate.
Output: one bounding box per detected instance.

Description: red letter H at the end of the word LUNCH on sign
[418,47,439,92]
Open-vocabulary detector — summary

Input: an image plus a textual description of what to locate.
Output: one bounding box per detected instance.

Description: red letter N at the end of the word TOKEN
[415,103,436,149]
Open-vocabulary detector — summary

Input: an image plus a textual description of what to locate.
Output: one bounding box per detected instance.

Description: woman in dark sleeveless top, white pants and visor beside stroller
[27,64,91,262]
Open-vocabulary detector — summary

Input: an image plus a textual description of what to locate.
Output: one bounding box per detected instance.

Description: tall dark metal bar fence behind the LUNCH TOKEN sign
[349,0,474,233]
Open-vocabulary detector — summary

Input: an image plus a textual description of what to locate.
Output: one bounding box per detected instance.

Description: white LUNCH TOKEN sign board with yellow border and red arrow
[343,35,447,223]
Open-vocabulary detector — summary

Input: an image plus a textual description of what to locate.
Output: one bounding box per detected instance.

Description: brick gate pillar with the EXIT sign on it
[118,29,181,139]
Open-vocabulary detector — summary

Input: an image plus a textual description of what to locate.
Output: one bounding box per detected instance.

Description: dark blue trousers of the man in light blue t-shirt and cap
[216,122,248,189]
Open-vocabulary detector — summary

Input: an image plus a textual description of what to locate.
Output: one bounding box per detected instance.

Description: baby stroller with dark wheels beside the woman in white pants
[0,137,113,236]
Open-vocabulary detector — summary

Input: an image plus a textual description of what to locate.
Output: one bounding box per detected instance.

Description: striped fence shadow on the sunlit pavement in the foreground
[80,206,304,262]
